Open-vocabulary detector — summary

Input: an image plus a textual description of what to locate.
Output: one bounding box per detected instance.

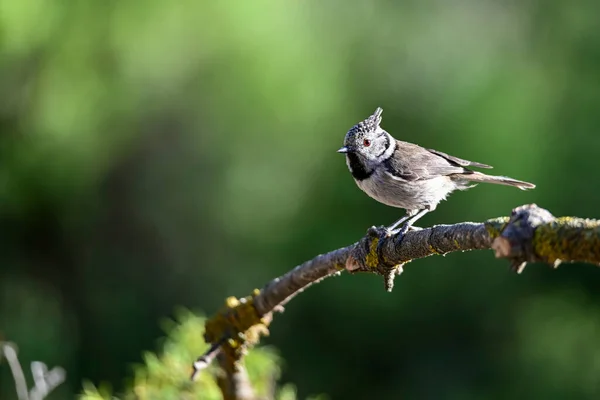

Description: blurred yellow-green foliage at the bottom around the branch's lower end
[79,311,310,400]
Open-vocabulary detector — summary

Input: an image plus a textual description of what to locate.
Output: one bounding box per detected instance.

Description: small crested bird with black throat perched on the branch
[338,107,535,237]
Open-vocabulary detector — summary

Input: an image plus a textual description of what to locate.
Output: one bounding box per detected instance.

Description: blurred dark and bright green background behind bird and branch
[0,0,600,399]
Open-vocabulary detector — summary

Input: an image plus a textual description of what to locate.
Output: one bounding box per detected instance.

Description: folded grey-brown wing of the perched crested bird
[384,141,491,181]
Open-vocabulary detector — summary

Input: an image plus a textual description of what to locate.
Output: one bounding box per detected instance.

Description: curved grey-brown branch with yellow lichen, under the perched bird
[194,204,600,399]
